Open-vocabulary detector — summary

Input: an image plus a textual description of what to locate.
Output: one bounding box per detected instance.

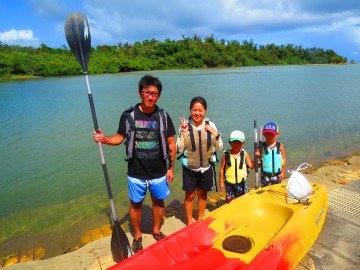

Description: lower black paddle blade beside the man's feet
[111,220,131,262]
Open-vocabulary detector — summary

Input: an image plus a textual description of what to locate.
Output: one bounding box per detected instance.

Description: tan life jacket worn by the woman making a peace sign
[178,118,217,169]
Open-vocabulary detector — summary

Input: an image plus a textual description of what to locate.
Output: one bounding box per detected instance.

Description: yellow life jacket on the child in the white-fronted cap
[224,149,248,184]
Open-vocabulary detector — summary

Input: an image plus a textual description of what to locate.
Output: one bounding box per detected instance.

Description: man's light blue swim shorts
[128,175,170,203]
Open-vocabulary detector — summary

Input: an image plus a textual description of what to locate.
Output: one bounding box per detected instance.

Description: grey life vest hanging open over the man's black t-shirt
[125,104,172,164]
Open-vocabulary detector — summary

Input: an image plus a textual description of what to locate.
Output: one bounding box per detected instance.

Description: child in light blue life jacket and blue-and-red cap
[260,122,286,186]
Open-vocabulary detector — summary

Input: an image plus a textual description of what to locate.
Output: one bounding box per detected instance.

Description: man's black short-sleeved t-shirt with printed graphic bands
[117,106,176,180]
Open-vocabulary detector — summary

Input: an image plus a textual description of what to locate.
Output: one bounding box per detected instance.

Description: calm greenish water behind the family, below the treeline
[0,65,360,256]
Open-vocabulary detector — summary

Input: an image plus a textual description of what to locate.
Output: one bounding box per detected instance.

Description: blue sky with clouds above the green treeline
[0,0,360,62]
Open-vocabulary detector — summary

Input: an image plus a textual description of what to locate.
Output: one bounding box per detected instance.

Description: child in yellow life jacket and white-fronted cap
[219,130,254,203]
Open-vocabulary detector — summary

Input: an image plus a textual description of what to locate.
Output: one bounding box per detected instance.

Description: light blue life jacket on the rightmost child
[261,141,283,175]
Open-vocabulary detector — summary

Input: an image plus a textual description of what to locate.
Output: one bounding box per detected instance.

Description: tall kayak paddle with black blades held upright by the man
[64,13,131,262]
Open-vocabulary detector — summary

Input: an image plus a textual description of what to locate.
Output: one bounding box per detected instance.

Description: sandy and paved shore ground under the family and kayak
[4,154,360,270]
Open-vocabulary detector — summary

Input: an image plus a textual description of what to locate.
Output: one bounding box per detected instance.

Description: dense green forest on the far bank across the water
[0,36,347,79]
